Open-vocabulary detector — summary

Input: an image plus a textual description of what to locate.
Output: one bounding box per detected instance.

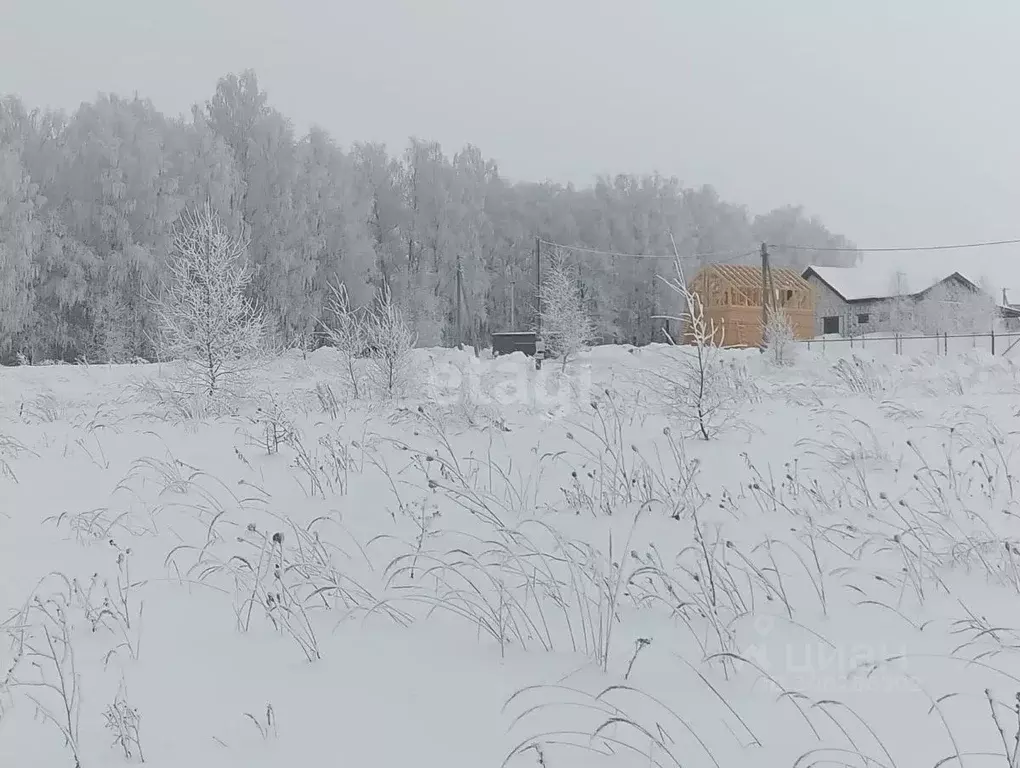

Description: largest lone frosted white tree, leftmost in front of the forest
[152,204,267,396]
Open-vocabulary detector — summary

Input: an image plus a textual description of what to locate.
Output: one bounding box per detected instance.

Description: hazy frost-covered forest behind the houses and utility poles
[0,70,856,362]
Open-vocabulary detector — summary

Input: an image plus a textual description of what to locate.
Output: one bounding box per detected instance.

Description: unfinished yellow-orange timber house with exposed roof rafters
[684,264,815,347]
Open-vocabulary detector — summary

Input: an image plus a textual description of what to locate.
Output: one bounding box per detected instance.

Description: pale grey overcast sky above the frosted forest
[0,0,1020,273]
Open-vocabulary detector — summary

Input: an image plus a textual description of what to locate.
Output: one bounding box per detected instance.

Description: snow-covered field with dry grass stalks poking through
[0,345,1020,768]
